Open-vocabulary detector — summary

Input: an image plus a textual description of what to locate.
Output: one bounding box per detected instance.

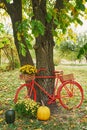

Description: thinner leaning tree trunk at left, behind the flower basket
[5,0,33,66]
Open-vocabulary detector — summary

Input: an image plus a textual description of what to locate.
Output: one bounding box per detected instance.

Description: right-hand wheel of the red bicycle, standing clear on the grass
[58,81,83,109]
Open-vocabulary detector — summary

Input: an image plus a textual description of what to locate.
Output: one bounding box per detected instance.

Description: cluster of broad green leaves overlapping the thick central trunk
[31,20,45,37]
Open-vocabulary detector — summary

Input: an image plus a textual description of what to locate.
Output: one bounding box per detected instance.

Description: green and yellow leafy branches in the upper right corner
[51,0,86,33]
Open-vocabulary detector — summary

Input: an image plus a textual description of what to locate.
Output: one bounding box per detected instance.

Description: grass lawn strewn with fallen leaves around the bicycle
[0,65,87,130]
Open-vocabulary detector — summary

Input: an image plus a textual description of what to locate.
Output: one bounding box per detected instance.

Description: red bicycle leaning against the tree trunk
[14,69,84,109]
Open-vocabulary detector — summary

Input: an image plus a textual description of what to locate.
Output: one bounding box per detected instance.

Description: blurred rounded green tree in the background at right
[57,33,87,62]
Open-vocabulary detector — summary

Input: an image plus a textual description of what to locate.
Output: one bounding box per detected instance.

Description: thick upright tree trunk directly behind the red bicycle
[32,0,57,112]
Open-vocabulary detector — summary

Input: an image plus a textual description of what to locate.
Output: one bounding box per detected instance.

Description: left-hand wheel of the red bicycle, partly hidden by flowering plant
[14,84,36,103]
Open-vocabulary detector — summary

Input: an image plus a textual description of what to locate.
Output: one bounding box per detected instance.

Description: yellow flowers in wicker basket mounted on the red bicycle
[20,64,37,81]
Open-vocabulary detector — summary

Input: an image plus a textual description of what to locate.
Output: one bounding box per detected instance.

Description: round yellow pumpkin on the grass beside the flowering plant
[37,101,50,121]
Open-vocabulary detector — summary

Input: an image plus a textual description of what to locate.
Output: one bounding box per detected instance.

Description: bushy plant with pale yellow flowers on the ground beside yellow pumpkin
[14,98,39,118]
